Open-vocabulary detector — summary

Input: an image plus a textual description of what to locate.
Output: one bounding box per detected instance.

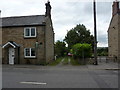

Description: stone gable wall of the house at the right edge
[108,14,119,57]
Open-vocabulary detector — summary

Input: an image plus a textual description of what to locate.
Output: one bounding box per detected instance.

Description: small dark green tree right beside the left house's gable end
[55,40,67,57]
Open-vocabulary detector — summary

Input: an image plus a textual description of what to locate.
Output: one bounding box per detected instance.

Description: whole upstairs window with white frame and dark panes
[24,27,36,38]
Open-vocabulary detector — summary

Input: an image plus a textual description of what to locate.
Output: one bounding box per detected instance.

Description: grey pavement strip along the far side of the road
[2,59,120,70]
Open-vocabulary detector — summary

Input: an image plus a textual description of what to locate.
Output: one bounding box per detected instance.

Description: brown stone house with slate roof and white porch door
[1,1,54,64]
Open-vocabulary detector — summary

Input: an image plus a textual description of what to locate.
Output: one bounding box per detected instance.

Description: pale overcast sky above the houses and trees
[0,0,114,47]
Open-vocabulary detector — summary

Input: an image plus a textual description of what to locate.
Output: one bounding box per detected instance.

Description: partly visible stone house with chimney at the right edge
[108,1,120,59]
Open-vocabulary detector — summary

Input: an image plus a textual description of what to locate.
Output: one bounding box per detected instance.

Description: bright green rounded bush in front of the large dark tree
[72,43,92,58]
